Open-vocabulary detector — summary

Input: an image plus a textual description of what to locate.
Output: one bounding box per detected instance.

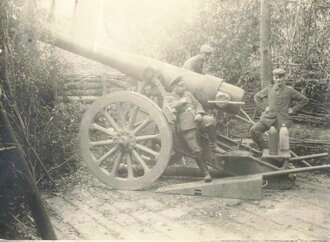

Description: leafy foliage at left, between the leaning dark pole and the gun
[2,0,80,184]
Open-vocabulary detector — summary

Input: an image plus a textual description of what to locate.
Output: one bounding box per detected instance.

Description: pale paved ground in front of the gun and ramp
[44,164,330,241]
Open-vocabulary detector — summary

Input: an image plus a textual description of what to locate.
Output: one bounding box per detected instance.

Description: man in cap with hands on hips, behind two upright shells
[250,69,308,150]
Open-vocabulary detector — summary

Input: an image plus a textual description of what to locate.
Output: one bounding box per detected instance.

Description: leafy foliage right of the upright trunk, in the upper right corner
[272,0,330,98]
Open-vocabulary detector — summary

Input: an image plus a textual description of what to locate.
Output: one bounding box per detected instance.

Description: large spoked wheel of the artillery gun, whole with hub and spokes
[79,91,173,190]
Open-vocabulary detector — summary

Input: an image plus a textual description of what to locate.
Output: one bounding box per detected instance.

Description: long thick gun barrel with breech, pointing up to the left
[45,32,244,113]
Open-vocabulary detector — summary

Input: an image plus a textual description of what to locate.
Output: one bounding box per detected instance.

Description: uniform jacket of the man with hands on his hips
[254,85,308,128]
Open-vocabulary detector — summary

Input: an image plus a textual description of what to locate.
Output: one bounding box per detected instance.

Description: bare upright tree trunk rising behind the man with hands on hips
[260,0,272,88]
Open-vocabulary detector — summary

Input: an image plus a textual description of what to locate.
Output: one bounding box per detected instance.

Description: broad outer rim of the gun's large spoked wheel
[79,91,173,190]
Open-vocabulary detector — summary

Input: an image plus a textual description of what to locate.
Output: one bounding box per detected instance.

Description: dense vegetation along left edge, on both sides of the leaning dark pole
[0,0,80,239]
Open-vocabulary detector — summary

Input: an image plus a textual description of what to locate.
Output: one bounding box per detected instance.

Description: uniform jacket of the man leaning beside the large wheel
[164,91,205,132]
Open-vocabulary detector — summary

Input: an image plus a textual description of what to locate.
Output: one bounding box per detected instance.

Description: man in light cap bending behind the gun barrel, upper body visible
[183,45,213,74]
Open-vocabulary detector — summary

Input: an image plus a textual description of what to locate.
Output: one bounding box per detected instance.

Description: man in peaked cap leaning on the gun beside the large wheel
[164,76,224,182]
